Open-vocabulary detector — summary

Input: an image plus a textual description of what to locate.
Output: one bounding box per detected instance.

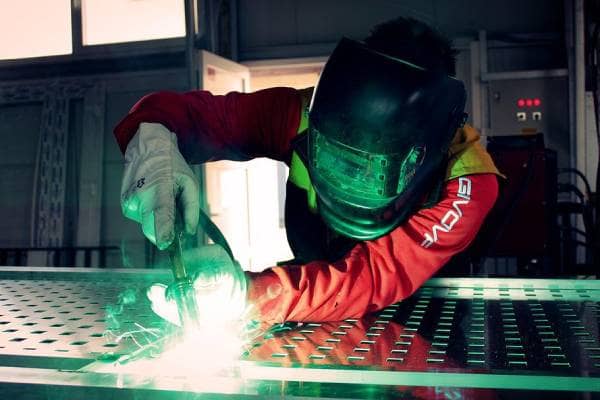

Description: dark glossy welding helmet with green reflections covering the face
[307,38,466,240]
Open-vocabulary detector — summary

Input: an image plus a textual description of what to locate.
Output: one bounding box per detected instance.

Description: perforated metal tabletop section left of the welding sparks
[0,274,163,359]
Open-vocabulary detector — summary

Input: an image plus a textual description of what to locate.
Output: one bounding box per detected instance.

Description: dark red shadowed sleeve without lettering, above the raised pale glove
[114,88,301,163]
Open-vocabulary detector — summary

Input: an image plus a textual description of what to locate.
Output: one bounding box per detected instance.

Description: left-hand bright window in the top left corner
[0,0,72,60]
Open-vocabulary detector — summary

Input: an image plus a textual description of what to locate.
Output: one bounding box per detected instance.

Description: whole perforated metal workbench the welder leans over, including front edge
[0,267,600,399]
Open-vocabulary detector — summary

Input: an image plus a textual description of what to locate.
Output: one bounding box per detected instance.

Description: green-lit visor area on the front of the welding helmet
[309,128,425,211]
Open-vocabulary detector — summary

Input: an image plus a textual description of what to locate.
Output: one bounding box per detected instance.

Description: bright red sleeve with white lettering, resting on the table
[249,174,498,323]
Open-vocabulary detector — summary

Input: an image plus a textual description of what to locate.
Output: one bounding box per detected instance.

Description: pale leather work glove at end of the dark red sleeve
[121,122,200,250]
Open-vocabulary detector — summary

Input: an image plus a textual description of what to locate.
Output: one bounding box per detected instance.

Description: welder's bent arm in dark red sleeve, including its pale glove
[114,88,303,249]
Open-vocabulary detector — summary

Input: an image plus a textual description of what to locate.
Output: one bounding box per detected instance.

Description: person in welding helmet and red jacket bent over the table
[115,18,499,323]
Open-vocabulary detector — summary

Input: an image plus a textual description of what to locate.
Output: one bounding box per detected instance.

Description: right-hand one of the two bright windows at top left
[81,0,185,45]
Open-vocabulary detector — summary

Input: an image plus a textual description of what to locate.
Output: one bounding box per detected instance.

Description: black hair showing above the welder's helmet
[364,17,458,76]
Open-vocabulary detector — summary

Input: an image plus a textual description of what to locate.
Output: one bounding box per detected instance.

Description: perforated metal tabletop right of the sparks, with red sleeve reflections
[244,287,600,377]
